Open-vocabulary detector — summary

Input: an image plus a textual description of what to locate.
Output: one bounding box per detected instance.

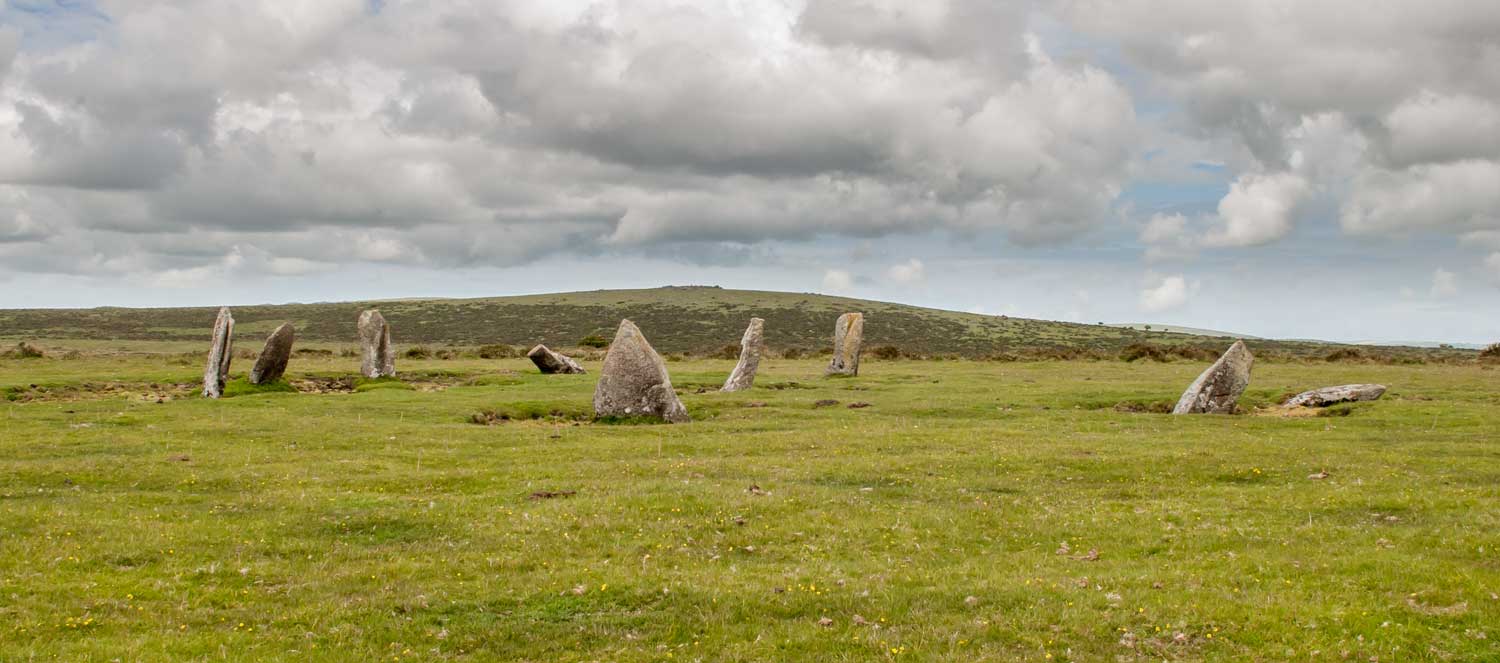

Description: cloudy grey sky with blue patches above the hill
[0,0,1500,342]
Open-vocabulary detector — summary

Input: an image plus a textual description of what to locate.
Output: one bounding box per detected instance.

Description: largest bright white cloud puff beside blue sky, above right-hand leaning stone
[1203,173,1310,246]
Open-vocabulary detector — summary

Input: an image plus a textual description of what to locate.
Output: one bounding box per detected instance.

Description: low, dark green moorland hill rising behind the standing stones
[0,287,1476,357]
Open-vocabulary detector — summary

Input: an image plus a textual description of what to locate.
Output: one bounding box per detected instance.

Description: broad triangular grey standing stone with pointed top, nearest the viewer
[594,320,692,423]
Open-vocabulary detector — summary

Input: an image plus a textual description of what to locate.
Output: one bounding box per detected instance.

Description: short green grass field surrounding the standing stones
[0,349,1500,662]
